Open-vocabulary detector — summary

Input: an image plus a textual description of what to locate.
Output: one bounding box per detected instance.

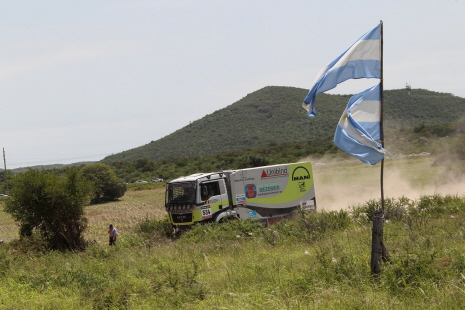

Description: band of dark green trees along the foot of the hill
[97,123,465,183]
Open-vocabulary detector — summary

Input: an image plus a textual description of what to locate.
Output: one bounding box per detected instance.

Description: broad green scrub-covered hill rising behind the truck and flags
[102,86,465,163]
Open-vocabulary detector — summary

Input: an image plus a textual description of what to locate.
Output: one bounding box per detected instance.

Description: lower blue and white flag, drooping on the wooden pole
[334,84,387,165]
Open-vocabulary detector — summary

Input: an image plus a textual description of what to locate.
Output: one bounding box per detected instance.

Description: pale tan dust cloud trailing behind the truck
[302,154,465,211]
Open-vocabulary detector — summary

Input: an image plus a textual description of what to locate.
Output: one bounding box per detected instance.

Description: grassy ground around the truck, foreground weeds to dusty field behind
[0,154,465,309]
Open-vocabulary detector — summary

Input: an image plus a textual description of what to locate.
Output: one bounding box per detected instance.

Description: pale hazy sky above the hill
[0,0,465,169]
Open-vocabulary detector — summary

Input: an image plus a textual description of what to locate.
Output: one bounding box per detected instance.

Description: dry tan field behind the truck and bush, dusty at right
[0,156,465,242]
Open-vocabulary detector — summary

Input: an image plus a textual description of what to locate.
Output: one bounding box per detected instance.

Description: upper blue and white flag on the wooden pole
[302,24,381,116]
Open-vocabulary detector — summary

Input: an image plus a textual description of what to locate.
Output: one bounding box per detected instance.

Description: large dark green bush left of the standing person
[4,167,89,250]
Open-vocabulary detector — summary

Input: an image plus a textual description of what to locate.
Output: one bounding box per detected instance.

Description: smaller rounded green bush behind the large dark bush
[81,163,126,203]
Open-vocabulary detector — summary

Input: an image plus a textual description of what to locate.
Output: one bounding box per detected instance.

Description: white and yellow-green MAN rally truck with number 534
[165,162,316,229]
